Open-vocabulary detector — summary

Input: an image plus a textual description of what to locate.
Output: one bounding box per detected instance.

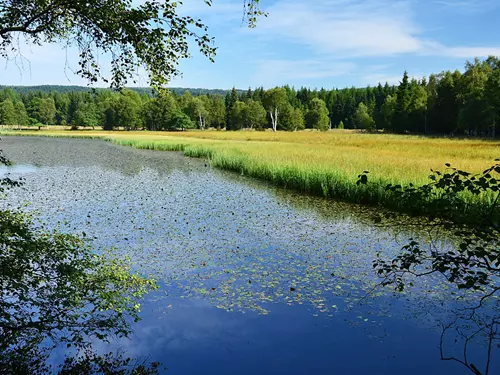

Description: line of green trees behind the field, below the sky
[0,56,500,137]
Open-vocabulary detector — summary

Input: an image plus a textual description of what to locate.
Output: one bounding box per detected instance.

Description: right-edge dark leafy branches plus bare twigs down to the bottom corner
[358,159,500,375]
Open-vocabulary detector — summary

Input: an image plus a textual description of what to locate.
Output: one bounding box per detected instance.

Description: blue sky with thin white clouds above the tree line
[0,0,500,88]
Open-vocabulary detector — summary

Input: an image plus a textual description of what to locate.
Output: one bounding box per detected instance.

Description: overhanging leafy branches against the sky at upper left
[0,0,262,87]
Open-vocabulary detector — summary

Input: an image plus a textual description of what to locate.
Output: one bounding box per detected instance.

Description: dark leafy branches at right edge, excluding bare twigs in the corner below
[358,159,500,296]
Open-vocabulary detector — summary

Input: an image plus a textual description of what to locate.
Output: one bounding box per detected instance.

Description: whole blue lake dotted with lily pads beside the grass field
[0,137,500,375]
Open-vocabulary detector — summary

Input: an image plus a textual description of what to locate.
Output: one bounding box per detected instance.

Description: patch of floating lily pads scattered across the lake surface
[0,140,484,330]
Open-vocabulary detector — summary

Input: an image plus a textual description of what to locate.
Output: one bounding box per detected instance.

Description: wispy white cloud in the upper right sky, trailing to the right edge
[252,0,500,59]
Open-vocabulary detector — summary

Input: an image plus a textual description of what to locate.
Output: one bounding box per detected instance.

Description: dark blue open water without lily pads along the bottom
[46,290,494,374]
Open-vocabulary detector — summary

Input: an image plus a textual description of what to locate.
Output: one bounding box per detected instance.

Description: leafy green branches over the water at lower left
[0,149,156,372]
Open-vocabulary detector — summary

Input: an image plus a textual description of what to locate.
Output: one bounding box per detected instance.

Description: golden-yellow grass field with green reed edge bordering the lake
[3,130,500,214]
